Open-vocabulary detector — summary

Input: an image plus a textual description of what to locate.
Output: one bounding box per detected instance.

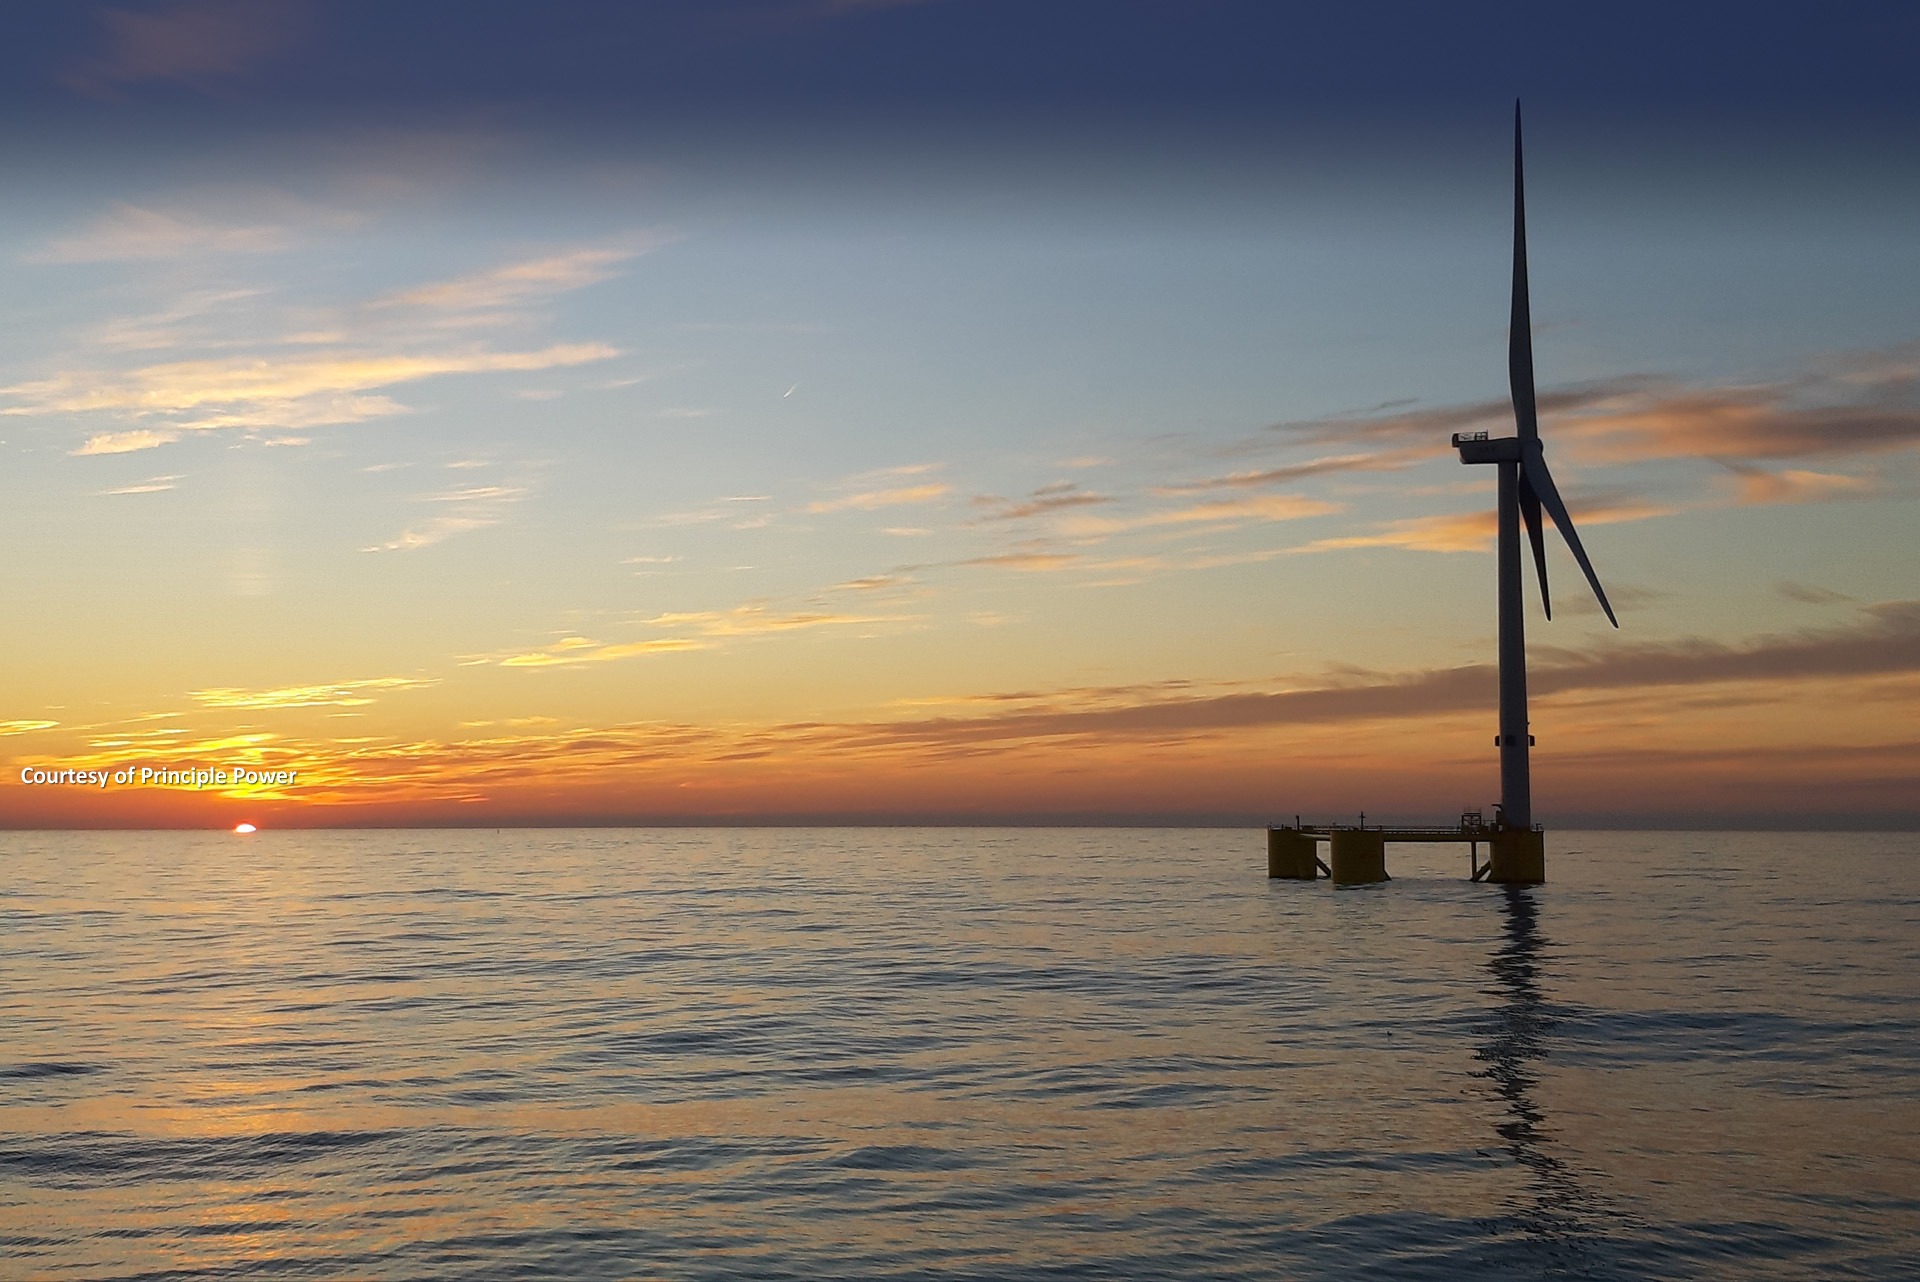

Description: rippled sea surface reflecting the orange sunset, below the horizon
[0,829,1920,1280]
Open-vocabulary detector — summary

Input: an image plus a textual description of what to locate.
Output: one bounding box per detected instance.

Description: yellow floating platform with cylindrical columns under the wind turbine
[1267,810,1548,887]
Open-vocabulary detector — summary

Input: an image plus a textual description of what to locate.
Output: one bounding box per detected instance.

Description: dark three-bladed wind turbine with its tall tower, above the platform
[1453,100,1620,840]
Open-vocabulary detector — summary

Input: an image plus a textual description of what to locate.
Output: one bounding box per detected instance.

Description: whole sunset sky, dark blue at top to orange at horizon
[0,0,1920,829]
